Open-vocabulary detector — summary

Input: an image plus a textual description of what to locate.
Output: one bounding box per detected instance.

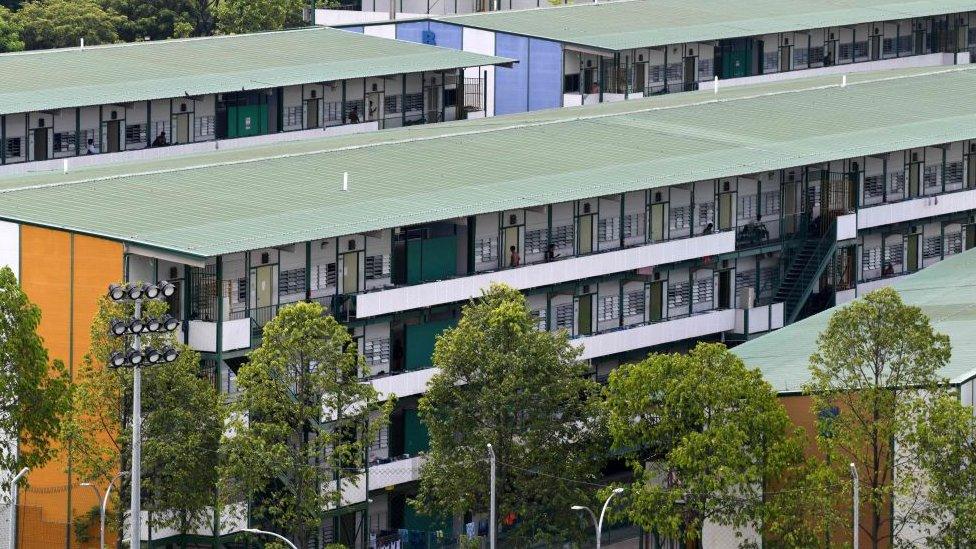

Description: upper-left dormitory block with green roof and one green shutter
[0,28,506,173]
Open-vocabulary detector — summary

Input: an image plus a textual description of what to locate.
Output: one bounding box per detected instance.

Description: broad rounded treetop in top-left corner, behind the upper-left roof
[14,0,125,50]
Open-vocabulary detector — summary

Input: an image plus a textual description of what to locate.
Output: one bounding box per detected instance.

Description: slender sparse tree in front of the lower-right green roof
[806,288,950,547]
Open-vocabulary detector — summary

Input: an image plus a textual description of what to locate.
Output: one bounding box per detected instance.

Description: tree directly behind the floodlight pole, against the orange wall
[62,297,226,533]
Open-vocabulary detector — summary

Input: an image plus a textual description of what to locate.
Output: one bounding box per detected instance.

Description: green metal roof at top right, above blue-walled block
[438,0,976,50]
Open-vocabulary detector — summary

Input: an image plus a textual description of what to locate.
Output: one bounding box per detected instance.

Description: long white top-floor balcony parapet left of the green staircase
[356,231,735,318]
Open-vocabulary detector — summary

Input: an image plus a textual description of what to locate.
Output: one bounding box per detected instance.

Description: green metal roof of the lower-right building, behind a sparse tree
[733,250,976,393]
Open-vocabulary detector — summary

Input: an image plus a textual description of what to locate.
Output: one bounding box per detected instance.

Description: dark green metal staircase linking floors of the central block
[774,221,837,324]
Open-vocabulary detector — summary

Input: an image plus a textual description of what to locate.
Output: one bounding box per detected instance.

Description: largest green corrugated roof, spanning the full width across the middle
[0,65,976,257]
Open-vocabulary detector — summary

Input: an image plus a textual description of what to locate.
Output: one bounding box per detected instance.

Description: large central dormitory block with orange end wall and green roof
[0,68,976,541]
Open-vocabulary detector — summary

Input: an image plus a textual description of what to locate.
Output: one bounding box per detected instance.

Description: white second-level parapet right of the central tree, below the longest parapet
[572,309,735,359]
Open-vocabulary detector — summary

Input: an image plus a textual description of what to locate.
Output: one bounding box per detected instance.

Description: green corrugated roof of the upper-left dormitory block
[0,28,511,114]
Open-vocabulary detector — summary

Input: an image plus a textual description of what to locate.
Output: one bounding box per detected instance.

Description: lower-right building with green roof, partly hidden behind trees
[732,245,976,547]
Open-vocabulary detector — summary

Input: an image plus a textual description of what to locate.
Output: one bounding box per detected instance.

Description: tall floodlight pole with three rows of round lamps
[108,280,179,547]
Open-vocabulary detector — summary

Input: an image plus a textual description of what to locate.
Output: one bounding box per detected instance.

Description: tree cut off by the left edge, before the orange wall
[0,266,70,498]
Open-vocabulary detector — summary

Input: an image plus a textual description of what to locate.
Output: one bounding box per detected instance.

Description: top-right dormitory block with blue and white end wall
[344,0,976,114]
